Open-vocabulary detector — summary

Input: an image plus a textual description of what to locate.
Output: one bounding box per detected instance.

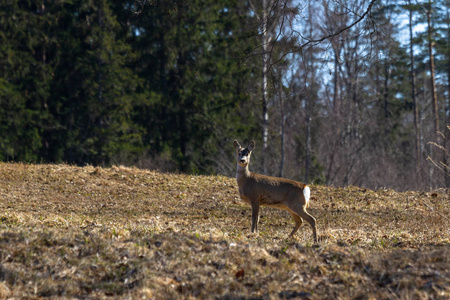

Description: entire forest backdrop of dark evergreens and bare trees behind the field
[0,0,450,190]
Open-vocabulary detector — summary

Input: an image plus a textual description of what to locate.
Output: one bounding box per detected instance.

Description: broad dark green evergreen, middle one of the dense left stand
[54,0,143,165]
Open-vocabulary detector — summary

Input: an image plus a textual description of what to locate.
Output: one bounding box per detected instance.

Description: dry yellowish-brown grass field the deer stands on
[0,163,450,299]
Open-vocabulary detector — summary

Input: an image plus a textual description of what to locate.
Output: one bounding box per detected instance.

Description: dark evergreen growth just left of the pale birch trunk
[128,0,256,172]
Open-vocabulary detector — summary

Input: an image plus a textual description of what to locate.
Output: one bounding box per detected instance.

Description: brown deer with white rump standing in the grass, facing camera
[233,140,317,243]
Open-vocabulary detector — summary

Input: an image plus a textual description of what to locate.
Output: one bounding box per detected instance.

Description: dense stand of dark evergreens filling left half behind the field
[0,0,256,172]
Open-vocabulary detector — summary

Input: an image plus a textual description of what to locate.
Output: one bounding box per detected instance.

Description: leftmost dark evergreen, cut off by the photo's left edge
[0,1,55,161]
